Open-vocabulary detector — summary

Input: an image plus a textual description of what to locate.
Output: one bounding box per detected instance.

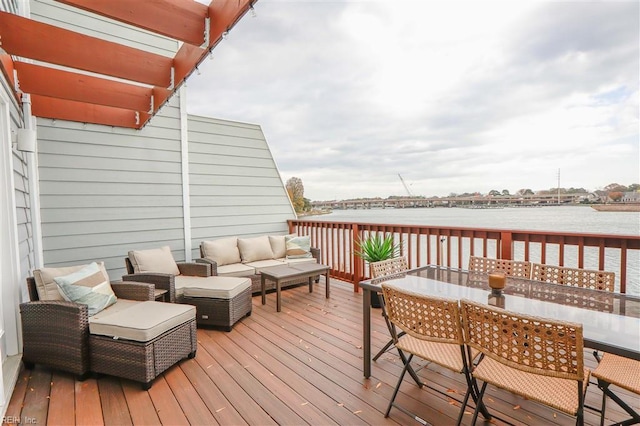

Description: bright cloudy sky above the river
[187,0,640,201]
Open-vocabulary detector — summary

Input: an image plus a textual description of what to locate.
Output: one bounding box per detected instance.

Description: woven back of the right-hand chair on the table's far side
[531,263,616,292]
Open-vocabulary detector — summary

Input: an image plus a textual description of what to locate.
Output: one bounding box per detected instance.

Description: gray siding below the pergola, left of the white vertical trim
[38,96,184,279]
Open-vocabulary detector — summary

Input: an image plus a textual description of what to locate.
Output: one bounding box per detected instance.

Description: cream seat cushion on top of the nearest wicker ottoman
[89,301,196,342]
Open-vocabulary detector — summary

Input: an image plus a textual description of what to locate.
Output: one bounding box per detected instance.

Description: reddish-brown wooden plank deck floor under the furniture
[4,280,640,425]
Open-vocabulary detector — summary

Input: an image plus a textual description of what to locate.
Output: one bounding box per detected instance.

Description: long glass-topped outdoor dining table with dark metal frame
[359,266,640,378]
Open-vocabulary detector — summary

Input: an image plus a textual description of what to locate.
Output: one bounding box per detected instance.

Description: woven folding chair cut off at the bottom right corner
[593,352,640,426]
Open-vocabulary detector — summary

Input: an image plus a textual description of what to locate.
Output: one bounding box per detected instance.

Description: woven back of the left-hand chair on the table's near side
[382,284,464,345]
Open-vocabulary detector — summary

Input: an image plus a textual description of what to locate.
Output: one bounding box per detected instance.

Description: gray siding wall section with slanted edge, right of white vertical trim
[188,115,295,258]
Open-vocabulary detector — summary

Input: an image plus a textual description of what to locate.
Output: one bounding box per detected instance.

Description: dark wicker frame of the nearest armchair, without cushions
[20,277,153,380]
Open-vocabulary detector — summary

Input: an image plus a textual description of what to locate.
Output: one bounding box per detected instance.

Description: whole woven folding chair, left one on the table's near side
[382,283,489,425]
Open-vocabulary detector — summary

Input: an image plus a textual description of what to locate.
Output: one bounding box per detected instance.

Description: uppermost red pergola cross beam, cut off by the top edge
[57,0,208,46]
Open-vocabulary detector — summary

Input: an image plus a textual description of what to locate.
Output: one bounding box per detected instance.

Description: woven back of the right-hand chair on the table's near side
[461,299,584,381]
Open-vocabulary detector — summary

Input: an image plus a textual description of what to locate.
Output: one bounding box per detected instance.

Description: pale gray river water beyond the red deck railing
[309,206,640,295]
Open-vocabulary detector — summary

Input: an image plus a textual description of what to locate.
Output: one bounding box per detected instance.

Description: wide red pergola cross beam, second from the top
[0,12,172,87]
